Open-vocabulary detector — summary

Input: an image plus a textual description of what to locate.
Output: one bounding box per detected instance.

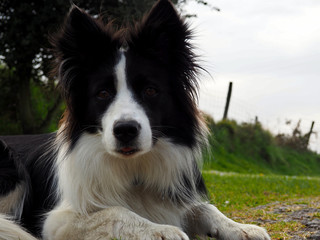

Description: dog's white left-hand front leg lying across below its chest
[43,204,189,240]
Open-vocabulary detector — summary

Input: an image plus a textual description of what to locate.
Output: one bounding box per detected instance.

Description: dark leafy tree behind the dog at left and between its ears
[0,0,212,134]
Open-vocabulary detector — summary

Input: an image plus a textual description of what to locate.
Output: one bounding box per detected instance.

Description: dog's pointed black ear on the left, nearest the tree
[50,5,119,95]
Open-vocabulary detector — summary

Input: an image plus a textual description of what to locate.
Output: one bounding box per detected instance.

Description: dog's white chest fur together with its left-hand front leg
[44,130,201,240]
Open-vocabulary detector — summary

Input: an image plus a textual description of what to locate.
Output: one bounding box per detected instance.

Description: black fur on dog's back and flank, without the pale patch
[0,134,57,236]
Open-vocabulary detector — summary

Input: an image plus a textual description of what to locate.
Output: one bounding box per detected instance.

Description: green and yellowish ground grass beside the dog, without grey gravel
[203,171,320,239]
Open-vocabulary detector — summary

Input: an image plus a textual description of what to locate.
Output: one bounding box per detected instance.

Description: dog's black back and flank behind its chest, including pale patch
[0,133,56,233]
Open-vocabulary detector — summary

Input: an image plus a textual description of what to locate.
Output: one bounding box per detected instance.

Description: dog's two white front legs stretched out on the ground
[44,204,270,240]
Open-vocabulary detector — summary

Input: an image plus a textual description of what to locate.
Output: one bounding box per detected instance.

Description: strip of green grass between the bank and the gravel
[203,171,320,211]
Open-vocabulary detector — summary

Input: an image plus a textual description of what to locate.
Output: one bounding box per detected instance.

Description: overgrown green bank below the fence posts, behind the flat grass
[204,117,320,176]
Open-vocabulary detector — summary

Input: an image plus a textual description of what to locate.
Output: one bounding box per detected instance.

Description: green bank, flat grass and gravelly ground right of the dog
[203,118,320,239]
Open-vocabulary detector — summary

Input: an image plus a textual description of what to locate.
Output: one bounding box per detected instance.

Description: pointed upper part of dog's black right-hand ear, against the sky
[128,0,193,64]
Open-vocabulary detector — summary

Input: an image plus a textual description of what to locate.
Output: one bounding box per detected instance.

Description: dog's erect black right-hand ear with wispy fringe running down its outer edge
[128,0,200,98]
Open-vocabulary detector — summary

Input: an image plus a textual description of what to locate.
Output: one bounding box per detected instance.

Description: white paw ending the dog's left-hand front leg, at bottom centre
[144,224,189,240]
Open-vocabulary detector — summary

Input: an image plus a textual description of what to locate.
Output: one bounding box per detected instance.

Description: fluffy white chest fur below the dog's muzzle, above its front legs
[57,134,195,221]
